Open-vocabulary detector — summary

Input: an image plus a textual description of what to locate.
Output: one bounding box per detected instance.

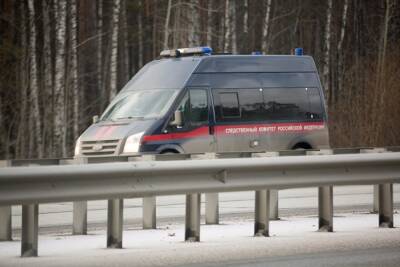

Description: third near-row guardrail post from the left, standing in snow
[185,193,201,242]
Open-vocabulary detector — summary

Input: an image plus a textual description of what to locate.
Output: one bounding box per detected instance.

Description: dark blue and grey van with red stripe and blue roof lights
[75,47,329,157]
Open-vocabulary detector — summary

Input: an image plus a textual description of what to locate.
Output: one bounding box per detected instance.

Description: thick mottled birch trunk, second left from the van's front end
[54,0,67,156]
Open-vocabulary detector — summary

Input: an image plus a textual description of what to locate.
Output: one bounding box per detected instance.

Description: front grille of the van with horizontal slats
[81,140,119,156]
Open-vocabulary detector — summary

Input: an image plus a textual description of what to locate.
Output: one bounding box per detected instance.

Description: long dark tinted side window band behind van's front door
[213,87,323,122]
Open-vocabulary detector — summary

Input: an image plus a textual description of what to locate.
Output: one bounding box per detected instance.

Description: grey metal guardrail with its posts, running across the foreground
[0,148,400,256]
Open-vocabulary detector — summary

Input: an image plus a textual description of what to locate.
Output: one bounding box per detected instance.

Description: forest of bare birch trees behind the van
[0,0,400,159]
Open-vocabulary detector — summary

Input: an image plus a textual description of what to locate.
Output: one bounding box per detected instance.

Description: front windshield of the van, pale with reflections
[101,89,179,121]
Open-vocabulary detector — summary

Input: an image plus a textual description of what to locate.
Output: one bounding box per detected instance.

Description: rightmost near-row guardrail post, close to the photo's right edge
[379,184,393,228]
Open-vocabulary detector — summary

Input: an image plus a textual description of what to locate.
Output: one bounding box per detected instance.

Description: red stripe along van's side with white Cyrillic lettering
[142,122,325,143]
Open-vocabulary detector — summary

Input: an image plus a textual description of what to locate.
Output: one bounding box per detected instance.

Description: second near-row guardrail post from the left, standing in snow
[107,199,124,248]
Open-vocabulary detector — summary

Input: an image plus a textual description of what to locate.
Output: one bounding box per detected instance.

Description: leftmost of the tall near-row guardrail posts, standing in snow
[21,204,39,257]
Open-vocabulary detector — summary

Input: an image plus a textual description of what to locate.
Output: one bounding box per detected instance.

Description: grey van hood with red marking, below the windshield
[80,119,155,141]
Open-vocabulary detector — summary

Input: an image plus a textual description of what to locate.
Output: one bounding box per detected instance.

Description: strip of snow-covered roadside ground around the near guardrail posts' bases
[0,211,400,267]
